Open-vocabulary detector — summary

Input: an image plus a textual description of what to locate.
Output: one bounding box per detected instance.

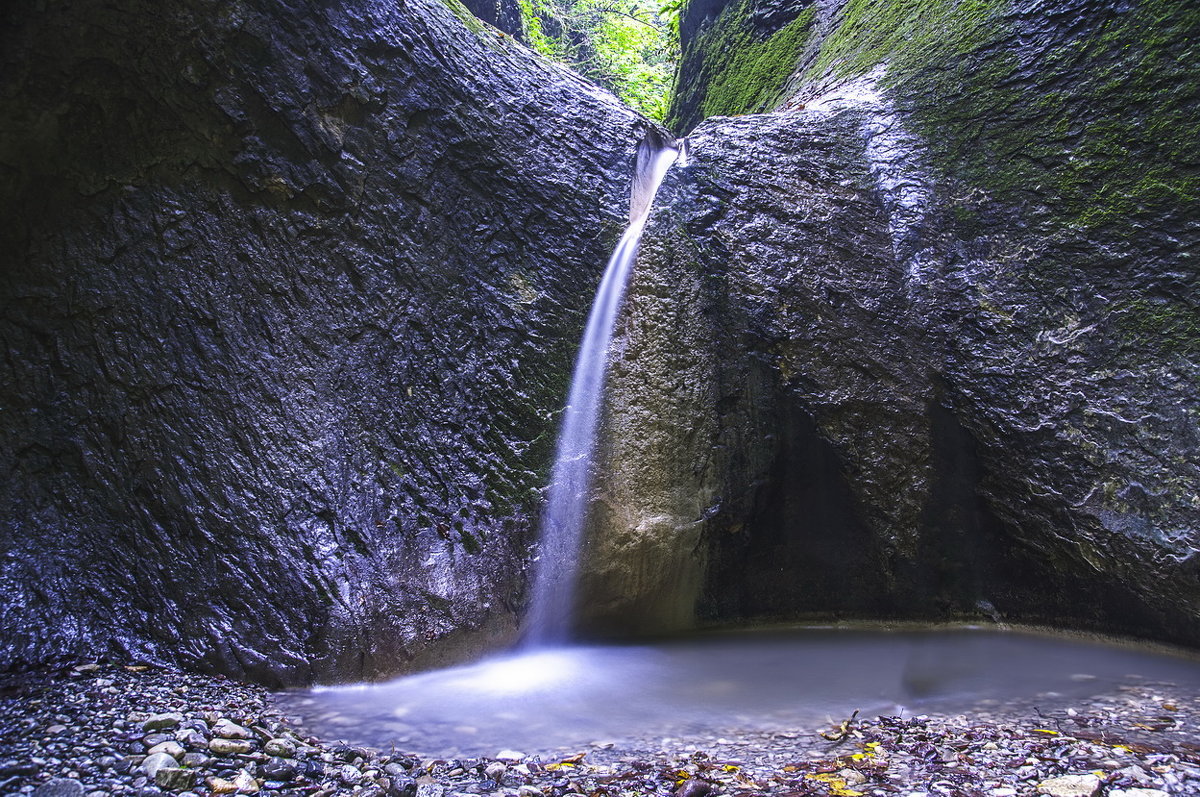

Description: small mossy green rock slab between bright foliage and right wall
[667,0,815,130]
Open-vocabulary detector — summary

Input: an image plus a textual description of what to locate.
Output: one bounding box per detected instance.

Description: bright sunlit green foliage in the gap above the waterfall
[518,0,678,121]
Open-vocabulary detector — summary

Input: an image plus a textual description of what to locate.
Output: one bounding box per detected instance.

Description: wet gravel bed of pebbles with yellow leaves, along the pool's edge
[0,664,1200,797]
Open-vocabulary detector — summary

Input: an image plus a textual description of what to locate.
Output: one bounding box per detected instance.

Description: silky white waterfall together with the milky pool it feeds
[280,140,1200,756]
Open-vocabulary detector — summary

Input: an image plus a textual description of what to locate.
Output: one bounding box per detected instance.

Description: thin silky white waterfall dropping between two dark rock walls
[523,136,678,647]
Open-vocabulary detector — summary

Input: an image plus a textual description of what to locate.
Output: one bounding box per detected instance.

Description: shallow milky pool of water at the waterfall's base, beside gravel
[280,628,1200,756]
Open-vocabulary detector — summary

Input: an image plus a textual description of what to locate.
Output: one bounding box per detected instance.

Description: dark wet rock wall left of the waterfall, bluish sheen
[0,0,643,683]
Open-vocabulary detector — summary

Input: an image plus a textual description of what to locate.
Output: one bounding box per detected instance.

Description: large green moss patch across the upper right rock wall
[805,0,1200,234]
